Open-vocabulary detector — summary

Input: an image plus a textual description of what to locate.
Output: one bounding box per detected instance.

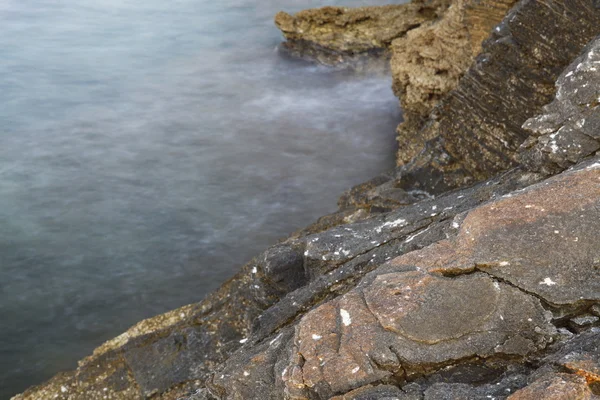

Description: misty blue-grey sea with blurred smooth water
[0,0,400,399]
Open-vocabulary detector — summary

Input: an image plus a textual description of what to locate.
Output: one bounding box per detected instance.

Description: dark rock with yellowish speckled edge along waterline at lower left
[15,253,305,400]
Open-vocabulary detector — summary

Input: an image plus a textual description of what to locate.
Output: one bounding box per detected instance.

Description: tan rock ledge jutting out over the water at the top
[275,0,450,68]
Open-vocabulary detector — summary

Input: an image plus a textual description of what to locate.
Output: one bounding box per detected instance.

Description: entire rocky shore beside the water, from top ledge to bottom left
[15,0,600,400]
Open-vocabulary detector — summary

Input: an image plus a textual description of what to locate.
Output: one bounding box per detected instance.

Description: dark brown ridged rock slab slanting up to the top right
[395,0,600,194]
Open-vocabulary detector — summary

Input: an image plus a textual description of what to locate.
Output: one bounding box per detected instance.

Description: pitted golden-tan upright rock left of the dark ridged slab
[391,0,516,165]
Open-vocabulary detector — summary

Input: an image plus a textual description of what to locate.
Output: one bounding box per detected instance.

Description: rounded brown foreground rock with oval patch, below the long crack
[284,271,553,398]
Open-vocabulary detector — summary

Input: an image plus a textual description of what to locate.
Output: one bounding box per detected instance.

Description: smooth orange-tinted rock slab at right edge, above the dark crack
[392,164,600,305]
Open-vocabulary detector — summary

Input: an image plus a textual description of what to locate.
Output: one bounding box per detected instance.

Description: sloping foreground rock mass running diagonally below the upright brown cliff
[16,157,600,400]
